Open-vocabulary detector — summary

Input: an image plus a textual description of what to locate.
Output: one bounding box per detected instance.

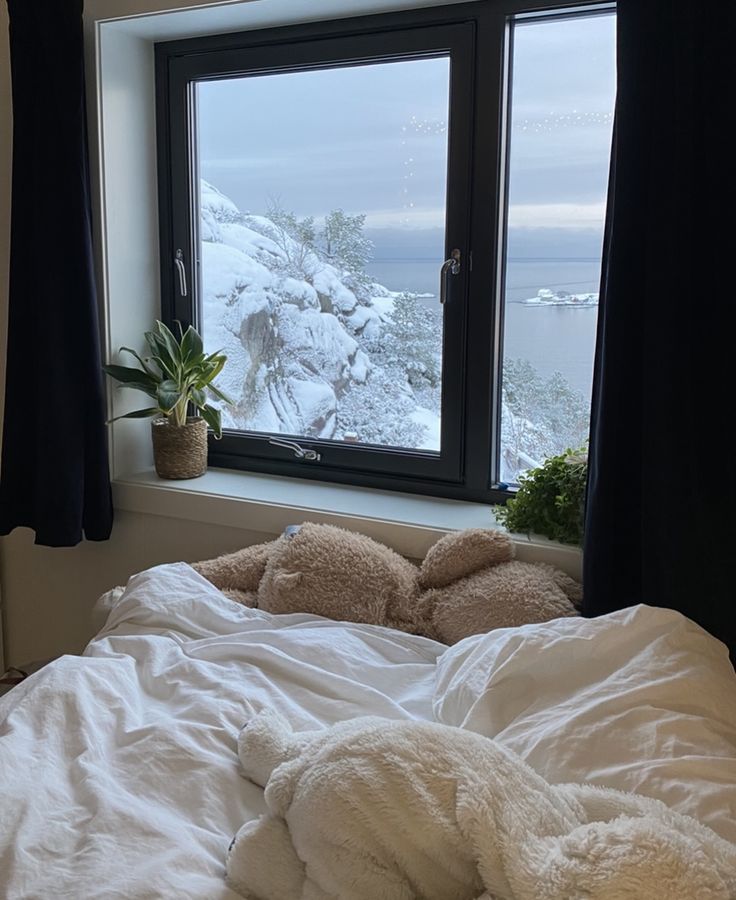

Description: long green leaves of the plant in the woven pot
[102,321,232,438]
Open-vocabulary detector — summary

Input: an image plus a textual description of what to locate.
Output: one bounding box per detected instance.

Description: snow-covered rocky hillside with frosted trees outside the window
[200,181,589,482]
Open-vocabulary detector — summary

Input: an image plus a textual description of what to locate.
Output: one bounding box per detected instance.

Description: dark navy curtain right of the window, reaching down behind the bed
[584,0,736,658]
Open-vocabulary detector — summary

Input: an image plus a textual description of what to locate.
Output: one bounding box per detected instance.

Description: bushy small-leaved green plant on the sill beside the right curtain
[494,450,588,544]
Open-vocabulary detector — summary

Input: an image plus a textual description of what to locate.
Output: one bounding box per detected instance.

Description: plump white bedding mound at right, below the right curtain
[433,606,736,843]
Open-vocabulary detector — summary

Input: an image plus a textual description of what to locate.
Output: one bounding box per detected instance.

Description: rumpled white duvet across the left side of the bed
[0,563,445,900]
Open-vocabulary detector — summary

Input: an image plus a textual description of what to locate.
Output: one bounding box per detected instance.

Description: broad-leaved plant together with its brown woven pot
[102,321,232,478]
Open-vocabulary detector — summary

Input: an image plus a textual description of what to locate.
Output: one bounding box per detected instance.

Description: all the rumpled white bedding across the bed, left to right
[0,563,736,900]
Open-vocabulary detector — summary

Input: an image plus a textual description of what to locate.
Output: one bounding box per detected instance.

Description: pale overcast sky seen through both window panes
[198,10,615,255]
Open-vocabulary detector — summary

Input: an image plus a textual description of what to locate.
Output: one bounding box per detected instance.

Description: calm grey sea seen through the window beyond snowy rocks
[367,253,600,397]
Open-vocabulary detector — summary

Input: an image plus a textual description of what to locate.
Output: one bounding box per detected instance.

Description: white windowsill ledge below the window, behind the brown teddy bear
[113,469,582,579]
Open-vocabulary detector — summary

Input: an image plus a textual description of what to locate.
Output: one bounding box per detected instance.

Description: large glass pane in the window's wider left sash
[196,56,450,451]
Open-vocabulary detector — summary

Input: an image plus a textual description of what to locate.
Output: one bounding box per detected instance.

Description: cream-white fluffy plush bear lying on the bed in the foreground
[227,711,736,900]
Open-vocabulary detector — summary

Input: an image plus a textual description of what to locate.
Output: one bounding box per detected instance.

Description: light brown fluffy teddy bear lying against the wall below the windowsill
[194,523,581,644]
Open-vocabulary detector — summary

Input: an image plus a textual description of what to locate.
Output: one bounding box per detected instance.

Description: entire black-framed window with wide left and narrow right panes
[156,2,613,501]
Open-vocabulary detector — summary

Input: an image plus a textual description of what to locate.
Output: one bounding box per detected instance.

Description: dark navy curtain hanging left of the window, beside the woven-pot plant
[0,0,112,547]
